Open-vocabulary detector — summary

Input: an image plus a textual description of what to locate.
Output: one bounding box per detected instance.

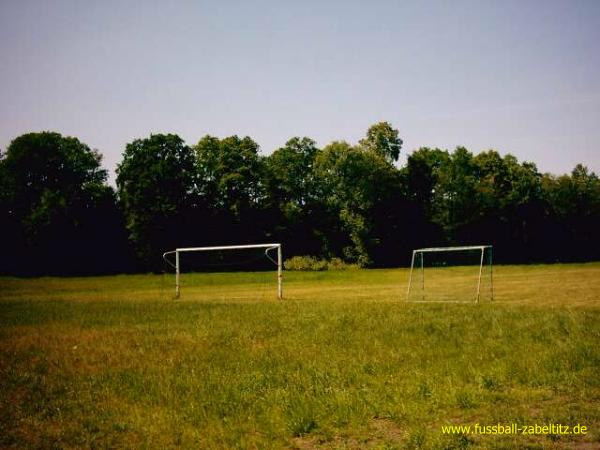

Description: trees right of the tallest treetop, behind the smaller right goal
[402,147,600,262]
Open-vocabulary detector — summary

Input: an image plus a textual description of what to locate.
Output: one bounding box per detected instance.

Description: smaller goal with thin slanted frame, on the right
[406,245,494,303]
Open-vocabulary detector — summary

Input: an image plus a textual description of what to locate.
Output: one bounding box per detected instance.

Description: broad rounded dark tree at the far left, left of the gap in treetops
[0,132,127,274]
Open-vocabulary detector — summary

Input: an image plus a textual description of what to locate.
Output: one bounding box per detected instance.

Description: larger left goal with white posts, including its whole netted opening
[163,243,283,299]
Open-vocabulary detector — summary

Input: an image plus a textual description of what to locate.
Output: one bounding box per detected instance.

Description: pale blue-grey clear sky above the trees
[0,0,600,183]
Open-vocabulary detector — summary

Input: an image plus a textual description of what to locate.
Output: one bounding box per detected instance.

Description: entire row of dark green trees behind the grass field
[0,122,600,275]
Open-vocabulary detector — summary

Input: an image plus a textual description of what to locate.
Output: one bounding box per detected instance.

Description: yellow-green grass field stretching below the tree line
[0,263,600,449]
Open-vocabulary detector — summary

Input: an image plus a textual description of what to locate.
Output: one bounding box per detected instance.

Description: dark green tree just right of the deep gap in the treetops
[117,134,197,270]
